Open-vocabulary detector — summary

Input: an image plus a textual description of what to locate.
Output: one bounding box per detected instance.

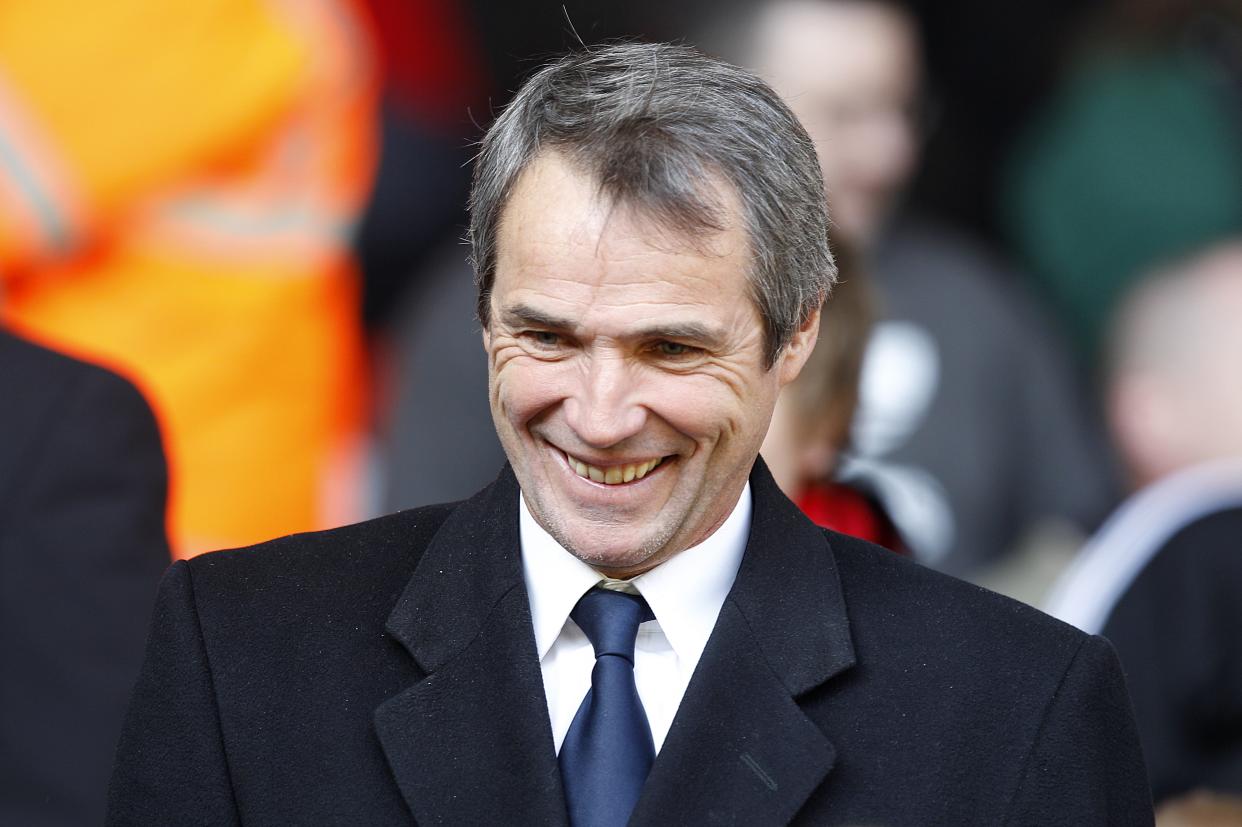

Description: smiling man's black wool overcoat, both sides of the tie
[109,462,1151,827]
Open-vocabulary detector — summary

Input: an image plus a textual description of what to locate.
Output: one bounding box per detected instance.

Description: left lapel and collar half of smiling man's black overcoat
[375,468,566,825]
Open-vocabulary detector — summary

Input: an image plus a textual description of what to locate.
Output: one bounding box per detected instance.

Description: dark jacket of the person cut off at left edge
[0,332,175,827]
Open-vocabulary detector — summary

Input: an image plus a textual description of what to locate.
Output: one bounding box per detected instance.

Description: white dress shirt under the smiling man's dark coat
[519,483,750,755]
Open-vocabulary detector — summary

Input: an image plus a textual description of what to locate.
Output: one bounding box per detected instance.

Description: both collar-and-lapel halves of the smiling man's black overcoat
[375,461,854,825]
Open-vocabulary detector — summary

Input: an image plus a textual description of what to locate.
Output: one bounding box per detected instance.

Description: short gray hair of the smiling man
[469,43,836,368]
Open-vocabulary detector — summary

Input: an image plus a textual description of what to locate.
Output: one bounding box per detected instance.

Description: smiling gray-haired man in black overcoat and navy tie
[111,45,1151,826]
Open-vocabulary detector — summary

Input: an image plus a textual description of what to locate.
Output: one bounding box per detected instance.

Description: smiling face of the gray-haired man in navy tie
[483,154,817,576]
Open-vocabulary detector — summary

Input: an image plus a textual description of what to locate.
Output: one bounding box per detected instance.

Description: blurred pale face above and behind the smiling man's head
[751,0,919,245]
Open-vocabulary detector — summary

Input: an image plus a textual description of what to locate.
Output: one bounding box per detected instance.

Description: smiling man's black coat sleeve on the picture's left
[107,561,240,827]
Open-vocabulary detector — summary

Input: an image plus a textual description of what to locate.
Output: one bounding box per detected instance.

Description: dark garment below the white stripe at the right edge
[1103,507,1242,801]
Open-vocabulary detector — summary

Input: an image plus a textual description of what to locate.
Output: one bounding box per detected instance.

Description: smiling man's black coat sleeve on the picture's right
[1005,637,1154,827]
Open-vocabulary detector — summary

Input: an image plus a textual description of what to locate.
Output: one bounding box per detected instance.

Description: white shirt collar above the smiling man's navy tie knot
[518,482,751,664]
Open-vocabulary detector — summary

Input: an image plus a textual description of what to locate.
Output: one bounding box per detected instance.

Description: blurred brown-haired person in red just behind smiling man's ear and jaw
[761,245,905,551]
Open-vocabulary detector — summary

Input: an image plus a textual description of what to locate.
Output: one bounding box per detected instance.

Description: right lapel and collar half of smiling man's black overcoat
[631,461,854,825]
